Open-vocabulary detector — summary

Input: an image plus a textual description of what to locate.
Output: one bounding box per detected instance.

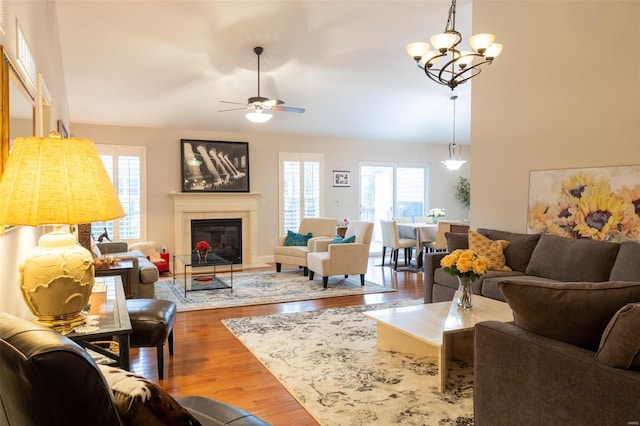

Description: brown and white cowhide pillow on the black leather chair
[98,365,200,426]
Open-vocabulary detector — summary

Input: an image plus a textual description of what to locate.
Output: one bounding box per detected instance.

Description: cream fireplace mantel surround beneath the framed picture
[169,192,262,266]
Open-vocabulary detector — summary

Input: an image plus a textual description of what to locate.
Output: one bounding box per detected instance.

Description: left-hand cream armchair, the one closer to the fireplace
[273,217,337,277]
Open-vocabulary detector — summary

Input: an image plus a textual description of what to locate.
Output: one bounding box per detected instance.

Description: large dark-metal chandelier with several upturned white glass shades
[407,0,502,90]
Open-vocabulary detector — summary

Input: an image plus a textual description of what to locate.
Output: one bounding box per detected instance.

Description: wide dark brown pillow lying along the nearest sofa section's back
[498,279,640,352]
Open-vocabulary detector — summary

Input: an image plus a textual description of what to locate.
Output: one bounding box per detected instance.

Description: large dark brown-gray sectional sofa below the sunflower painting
[424,229,640,426]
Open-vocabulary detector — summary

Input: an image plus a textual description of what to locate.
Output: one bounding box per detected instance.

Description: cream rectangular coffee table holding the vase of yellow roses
[364,295,513,392]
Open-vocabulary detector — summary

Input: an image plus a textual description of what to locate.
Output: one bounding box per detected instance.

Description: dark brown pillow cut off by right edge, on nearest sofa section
[596,303,640,370]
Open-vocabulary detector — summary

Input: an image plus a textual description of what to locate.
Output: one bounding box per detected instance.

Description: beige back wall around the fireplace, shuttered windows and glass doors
[72,123,469,262]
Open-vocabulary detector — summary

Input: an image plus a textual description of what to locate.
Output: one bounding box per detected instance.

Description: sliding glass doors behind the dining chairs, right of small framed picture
[360,163,428,241]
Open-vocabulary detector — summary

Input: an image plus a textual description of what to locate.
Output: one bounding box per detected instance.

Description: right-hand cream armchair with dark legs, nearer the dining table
[307,221,373,288]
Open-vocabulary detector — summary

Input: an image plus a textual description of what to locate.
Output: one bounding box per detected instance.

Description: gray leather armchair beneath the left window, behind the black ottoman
[96,241,160,299]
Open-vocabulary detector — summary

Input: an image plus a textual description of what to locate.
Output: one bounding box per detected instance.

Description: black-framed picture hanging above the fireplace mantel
[180,139,249,192]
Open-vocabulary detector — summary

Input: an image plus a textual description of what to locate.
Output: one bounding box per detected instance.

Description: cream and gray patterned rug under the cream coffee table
[223,299,473,426]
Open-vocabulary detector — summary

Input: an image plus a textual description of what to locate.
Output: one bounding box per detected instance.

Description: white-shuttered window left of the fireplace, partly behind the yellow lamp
[91,145,147,242]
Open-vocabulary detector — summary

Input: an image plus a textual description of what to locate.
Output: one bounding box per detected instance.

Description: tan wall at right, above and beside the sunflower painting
[471,0,640,232]
